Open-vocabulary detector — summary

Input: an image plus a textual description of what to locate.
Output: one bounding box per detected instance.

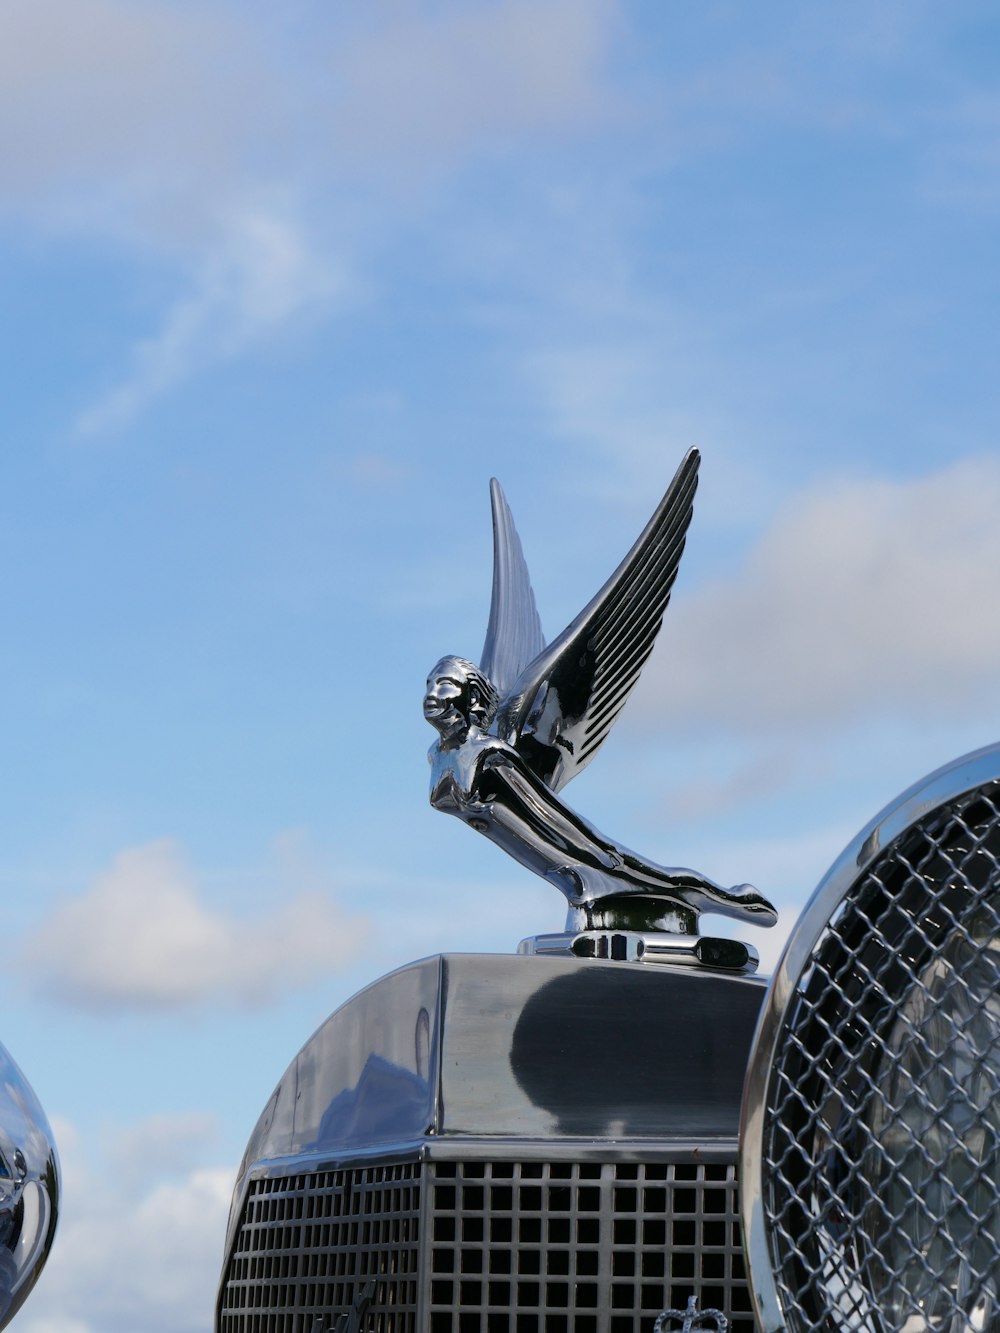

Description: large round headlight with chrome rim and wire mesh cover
[740,746,1000,1333]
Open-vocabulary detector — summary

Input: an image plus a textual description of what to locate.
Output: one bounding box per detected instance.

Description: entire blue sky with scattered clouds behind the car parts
[0,0,1000,1333]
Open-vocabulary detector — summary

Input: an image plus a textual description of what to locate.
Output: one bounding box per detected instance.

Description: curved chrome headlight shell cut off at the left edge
[0,1046,60,1328]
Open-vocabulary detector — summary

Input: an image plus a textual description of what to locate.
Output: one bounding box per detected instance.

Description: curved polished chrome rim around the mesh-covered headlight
[740,744,1000,1333]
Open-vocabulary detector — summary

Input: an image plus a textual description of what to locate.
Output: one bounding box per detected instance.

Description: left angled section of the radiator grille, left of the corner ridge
[219,1162,419,1333]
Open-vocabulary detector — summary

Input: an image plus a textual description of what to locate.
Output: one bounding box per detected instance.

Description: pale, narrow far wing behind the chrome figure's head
[479,477,545,698]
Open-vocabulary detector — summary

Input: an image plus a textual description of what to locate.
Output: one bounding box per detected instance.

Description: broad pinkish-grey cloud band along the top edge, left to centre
[0,0,615,221]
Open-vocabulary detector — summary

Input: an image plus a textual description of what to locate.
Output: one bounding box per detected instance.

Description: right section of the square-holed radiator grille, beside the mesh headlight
[428,1161,753,1333]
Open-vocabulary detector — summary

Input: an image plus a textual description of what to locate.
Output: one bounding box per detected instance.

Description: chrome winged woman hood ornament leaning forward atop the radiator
[424,449,776,934]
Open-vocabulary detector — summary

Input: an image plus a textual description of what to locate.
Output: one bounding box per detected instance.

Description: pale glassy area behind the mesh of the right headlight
[864,902,1000,1330]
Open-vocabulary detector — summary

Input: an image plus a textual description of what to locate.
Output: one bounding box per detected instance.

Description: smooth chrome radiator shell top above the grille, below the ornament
[225,954,764,1313]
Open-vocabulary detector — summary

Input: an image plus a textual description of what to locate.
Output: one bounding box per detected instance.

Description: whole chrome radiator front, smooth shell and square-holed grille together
[216,954,764,1333]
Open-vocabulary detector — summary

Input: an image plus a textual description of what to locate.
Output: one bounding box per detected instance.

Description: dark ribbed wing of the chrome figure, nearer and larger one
[491,449,700,792]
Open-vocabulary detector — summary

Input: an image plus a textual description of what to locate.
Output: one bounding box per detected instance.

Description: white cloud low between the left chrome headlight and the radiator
[17,1116,235,1333]
